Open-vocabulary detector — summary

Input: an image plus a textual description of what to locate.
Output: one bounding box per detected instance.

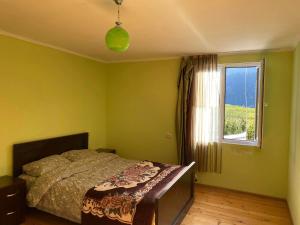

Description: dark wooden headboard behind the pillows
[13,133,89,177]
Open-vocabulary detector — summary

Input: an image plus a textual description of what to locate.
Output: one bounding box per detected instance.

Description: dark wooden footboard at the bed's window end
[155,162,195,225]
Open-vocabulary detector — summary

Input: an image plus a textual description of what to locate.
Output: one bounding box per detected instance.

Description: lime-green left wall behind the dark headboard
[0,36,106,175]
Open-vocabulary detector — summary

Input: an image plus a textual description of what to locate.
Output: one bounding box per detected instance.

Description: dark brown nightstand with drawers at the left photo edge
[0,176,26,225]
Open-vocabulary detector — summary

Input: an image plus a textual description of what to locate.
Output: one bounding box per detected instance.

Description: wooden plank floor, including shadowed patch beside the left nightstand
[24,185,292,225]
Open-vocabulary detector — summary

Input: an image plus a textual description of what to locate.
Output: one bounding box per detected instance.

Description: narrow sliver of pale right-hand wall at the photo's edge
[288,43,300,225]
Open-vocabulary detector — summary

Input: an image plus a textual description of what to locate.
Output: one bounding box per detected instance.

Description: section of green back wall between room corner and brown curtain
[107,60,180,163]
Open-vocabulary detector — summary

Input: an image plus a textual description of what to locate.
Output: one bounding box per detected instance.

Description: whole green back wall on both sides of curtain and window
[107,52,293,198]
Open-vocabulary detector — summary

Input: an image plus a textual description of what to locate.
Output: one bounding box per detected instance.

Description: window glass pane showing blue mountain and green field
[224,67,259,141]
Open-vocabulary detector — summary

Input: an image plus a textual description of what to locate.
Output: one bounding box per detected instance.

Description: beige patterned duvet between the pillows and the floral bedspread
[23,153,138,223]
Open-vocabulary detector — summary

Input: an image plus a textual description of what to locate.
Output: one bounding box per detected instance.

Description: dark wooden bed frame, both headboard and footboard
[13,133,195,225]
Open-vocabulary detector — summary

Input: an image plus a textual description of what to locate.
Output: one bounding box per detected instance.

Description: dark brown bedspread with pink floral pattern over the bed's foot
[81,161,181,225]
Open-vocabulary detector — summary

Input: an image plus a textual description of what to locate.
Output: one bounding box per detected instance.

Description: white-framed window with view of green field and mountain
[219,62,263,146]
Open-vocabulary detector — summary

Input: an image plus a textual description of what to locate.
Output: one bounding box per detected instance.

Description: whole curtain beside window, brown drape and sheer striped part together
[176,55,222,173]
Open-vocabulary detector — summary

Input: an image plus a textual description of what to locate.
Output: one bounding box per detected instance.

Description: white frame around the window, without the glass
[218,61,264,148]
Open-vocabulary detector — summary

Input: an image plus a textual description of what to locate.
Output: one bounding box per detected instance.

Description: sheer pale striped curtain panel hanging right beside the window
[192,55,222,173]
